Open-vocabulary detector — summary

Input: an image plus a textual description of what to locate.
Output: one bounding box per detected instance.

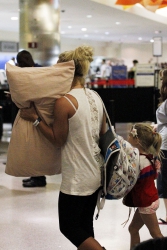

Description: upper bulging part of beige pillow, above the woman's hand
[6,61,74,108]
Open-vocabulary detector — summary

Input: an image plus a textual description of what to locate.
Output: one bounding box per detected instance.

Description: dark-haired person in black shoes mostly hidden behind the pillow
[16,50,47,188]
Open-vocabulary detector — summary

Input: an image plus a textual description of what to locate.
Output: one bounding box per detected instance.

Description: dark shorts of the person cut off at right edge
[157,150,167,199]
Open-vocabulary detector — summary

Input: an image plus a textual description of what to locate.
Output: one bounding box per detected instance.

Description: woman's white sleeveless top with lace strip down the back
[60,89,104,196]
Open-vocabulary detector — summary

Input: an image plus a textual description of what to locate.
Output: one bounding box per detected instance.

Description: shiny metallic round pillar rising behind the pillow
[19,0,60,66]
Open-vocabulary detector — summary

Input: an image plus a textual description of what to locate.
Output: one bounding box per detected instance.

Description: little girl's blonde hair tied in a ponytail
[132,123,162,157]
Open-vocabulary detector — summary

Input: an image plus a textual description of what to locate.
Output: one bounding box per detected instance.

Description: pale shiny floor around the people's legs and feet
[0,124,167,250]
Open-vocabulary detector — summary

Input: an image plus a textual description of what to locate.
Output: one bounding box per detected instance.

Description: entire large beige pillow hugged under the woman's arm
[5,61,74,177]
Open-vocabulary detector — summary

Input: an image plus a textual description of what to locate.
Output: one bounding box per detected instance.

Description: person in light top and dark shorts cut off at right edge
[154,69,167,224]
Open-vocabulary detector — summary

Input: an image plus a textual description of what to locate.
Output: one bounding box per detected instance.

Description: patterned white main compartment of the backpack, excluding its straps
[103,136,139,200]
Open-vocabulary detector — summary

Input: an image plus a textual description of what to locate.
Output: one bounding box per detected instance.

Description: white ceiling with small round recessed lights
[0,0,167,43]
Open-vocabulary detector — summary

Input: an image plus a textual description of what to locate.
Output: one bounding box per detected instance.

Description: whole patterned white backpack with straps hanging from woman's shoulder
[96,94,139,219]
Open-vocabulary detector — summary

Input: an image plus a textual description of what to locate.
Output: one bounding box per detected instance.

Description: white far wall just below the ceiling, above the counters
[61,37,167,68]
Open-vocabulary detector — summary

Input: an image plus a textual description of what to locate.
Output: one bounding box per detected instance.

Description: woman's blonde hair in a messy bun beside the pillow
[58,45,93,87]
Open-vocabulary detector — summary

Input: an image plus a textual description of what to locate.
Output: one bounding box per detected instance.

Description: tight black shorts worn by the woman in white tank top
[59,189,99,248]
